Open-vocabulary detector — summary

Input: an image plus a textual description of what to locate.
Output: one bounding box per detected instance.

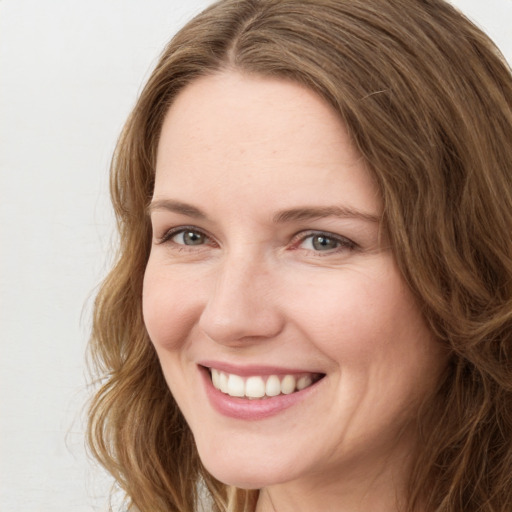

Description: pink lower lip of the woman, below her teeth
[201,368,323,421]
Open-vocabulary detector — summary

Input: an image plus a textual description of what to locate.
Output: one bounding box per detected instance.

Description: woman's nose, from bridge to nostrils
[199,255,284,346]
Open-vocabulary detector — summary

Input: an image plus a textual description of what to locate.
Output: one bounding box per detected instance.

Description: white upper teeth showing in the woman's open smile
[208,368,325,400]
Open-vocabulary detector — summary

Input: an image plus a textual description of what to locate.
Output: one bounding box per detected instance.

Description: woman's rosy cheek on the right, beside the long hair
[290,260,437,373]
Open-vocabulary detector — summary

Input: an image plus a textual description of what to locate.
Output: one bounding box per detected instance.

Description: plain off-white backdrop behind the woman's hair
[0,0,512,512]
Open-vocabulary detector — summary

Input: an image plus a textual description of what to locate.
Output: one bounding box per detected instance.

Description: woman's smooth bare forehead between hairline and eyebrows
[155,72,378,213]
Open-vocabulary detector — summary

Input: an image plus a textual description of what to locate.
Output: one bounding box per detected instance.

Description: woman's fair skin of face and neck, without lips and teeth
[143,71,445,512]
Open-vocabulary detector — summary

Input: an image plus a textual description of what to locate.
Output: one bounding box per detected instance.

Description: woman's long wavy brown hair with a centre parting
[89,0,512,512]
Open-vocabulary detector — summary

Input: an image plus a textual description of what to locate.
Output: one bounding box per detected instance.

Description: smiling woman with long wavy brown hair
[89,0,512,512]
